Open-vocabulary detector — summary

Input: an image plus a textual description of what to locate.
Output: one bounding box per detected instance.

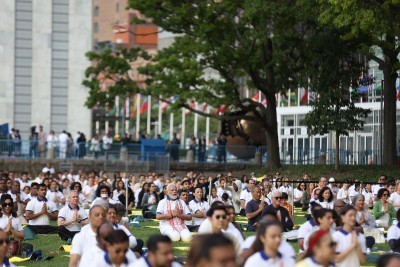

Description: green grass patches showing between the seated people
[15,209,389,267]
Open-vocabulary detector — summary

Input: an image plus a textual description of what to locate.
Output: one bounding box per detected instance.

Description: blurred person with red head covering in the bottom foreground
[295,229,336,267]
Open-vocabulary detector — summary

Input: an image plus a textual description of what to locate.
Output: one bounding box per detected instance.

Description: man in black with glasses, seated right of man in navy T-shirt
[261,191,293,232]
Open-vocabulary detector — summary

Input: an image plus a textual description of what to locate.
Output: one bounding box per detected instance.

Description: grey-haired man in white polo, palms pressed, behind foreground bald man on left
[57,190,89,240]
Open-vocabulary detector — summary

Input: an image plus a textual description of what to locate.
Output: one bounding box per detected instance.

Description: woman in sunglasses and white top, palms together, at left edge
[0,194,25,240]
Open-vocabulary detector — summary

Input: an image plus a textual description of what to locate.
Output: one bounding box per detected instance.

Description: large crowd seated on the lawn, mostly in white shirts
[0,169,400,267]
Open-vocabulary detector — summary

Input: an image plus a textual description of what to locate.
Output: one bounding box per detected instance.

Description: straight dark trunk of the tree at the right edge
[381,66,397,166]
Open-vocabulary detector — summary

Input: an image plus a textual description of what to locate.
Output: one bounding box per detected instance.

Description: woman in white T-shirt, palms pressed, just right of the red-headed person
[332,205,367,267]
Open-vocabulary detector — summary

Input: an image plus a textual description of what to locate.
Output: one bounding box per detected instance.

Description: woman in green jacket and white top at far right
[373,188,396,227]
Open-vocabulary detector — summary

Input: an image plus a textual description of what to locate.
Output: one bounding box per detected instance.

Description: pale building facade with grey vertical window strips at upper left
[0,0,92,139]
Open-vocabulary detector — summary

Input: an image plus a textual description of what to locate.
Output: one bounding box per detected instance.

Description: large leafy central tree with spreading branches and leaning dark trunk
[129,0,332,167]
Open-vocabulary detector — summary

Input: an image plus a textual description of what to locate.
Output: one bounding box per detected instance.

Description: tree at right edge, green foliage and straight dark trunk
[320,0,400,165]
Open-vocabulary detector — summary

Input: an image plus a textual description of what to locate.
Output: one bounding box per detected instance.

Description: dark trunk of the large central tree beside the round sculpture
[266,97,281,169]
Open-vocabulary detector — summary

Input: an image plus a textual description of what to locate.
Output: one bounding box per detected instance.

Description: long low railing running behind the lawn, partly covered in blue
[0,140,390,165]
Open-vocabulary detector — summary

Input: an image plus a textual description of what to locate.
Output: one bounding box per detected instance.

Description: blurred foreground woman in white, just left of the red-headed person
[244,221,295,267]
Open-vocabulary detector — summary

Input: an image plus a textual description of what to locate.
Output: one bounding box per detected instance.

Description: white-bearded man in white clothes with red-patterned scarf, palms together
[156,183,192,242]
